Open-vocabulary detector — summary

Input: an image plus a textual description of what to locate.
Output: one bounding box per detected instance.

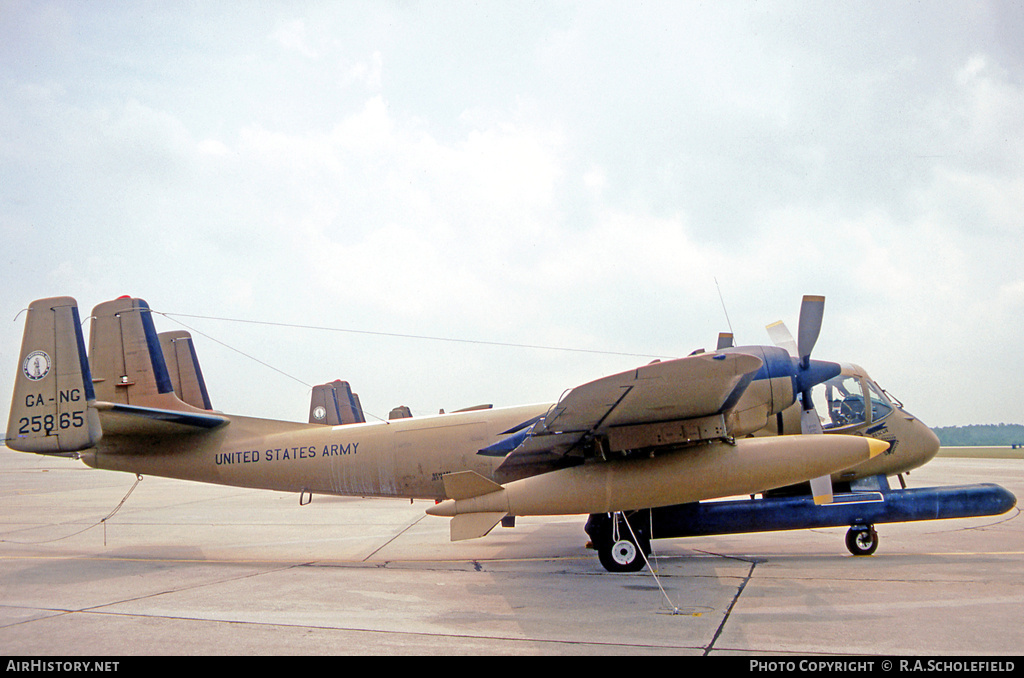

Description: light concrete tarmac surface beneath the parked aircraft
[0,449,1024,656]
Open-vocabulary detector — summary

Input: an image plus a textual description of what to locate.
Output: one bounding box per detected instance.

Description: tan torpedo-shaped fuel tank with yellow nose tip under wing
[427,435,889,540]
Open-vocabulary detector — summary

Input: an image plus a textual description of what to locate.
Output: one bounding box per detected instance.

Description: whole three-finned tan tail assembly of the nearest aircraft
[4,297,229,455]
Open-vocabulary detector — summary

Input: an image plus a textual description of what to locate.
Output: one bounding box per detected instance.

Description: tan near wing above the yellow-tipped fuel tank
[480,353,762,474]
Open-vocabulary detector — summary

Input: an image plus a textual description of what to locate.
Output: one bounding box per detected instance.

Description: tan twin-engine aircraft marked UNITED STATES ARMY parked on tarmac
[6,297,1012,570]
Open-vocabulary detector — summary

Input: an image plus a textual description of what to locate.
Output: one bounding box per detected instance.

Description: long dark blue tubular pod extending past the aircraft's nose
[650,483,1017,539]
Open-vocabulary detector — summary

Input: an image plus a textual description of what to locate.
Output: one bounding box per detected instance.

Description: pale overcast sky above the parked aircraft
[0,0,1024,426]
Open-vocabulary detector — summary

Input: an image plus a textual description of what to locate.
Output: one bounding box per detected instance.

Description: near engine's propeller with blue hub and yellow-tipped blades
[768,295,835,504]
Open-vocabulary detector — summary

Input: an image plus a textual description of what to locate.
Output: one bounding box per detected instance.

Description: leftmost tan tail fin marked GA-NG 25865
[5,297,102,455]
